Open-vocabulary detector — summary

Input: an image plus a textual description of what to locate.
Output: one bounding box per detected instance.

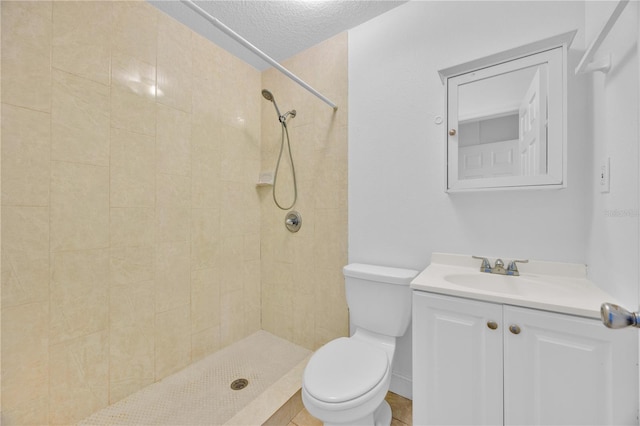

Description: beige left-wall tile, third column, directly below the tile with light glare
[110,128,156,207]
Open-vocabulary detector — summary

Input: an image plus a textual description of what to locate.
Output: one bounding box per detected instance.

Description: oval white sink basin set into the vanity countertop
[443,272,540,296]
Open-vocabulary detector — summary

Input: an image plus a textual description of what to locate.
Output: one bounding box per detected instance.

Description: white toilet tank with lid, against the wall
[343,263,418,337]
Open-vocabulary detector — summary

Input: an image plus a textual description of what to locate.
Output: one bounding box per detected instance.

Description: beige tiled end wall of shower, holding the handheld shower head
[259,33,349,350]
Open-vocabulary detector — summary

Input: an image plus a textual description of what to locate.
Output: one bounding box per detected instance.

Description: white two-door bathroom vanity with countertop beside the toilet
[411,253,638,425]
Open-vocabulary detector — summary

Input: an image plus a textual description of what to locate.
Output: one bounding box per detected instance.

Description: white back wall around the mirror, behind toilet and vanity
[349,1,596,396]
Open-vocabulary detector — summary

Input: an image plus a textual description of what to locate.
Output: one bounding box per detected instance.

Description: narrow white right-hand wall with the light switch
[585,2,639,309]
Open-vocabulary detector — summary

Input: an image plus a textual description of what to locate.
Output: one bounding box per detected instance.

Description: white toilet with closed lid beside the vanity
[302,263,418,426]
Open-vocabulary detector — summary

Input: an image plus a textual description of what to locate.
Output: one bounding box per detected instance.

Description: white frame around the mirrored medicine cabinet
[438,30,577,193]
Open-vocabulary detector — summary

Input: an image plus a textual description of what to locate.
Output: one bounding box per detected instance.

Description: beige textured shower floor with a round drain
[79,331,311,426]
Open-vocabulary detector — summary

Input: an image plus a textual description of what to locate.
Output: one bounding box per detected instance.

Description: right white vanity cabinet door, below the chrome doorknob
[504,306,638,425]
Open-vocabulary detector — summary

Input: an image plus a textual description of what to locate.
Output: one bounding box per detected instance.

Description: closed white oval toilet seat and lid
[303,337,389,403]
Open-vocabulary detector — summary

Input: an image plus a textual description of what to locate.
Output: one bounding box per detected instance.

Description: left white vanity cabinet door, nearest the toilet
[413,291,502,425]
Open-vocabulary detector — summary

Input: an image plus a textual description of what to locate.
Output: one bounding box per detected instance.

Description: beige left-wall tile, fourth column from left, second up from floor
[155,242,191,314]
